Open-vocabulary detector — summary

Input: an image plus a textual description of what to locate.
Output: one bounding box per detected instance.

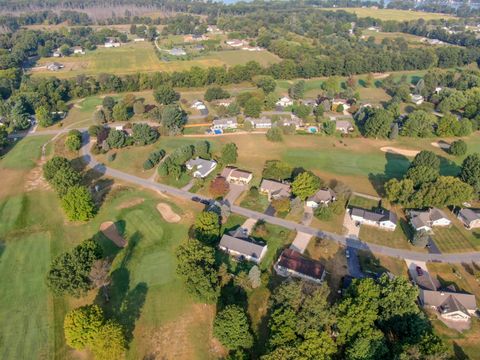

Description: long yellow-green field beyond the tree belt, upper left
[32,42,280,78]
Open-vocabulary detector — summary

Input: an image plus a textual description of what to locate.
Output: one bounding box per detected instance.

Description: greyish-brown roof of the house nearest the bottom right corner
[419,289,477,313]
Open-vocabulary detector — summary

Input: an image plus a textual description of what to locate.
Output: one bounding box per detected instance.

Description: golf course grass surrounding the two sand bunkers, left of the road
[0,137,223,359]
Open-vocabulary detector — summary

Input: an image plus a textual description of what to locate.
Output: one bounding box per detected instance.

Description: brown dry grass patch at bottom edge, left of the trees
[136,304,227,360]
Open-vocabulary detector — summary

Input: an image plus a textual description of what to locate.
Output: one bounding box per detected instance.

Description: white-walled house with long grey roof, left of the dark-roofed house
[218,235,267,264]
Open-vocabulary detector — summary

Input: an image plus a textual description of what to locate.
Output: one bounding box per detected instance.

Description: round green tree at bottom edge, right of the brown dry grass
[213,305,253,350]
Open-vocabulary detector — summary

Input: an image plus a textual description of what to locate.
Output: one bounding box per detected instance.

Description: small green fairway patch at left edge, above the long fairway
[0,135,51,170]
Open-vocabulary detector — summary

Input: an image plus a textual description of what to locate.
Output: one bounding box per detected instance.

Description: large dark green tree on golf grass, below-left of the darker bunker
[47,239,102,297]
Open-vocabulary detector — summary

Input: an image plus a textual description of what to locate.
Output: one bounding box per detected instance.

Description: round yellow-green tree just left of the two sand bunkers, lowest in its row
[62,185,96,221]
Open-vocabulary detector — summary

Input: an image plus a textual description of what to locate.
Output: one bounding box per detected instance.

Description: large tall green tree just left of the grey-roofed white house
[176,239,220,303]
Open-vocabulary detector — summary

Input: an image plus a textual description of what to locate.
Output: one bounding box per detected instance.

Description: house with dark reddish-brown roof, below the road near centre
[274,249,325,283]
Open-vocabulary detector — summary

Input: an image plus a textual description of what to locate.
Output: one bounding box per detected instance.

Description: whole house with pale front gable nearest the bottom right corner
[419,289,477,321]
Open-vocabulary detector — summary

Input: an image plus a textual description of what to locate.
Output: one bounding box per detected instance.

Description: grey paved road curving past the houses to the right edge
[66,133,480,263]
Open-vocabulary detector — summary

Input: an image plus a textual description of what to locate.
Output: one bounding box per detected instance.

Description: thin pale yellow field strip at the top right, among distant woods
[334,8,455,21]
